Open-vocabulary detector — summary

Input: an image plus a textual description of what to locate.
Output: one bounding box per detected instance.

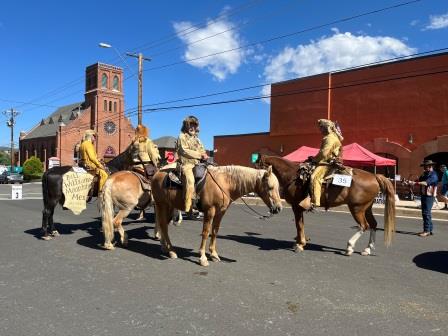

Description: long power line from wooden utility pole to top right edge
[145,0,423,71]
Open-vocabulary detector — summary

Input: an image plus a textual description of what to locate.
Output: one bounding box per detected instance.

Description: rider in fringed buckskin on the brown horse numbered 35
[301,119,344,209]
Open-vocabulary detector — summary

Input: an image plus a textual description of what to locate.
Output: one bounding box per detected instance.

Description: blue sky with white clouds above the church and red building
[0,0,448,148]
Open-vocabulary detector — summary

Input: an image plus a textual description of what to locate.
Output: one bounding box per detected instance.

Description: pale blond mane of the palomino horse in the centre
[209,165,266,195]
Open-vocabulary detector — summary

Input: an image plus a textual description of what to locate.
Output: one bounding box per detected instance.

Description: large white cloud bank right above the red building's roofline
[262,29,416,101]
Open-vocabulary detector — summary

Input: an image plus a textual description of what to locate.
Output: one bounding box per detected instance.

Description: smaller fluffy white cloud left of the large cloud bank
[174,18,245,81]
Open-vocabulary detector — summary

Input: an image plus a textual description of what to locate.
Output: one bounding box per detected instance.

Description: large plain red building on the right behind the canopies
[214,53,448,177]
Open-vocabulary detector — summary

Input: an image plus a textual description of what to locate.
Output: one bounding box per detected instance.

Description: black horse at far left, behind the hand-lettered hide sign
[42,146,130,240]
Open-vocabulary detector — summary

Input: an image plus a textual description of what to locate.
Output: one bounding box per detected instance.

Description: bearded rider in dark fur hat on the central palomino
[177,116,208,212]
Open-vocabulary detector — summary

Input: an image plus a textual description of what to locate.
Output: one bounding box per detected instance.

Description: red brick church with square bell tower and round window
[19,63,134,167]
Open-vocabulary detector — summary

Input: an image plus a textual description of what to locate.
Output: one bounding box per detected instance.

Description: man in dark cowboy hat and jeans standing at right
[412,160,439,237]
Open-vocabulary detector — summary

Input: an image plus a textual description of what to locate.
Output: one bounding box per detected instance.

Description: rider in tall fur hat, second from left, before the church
[131,125,160,178]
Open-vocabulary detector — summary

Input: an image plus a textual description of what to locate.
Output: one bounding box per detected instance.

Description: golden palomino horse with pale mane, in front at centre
[152,166,282,266]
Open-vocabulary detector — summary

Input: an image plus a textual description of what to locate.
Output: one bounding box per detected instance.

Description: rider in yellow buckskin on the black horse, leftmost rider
[79,130,108,192]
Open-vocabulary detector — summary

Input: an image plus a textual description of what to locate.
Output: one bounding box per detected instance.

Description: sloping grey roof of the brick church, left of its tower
[22,103,84,139]
